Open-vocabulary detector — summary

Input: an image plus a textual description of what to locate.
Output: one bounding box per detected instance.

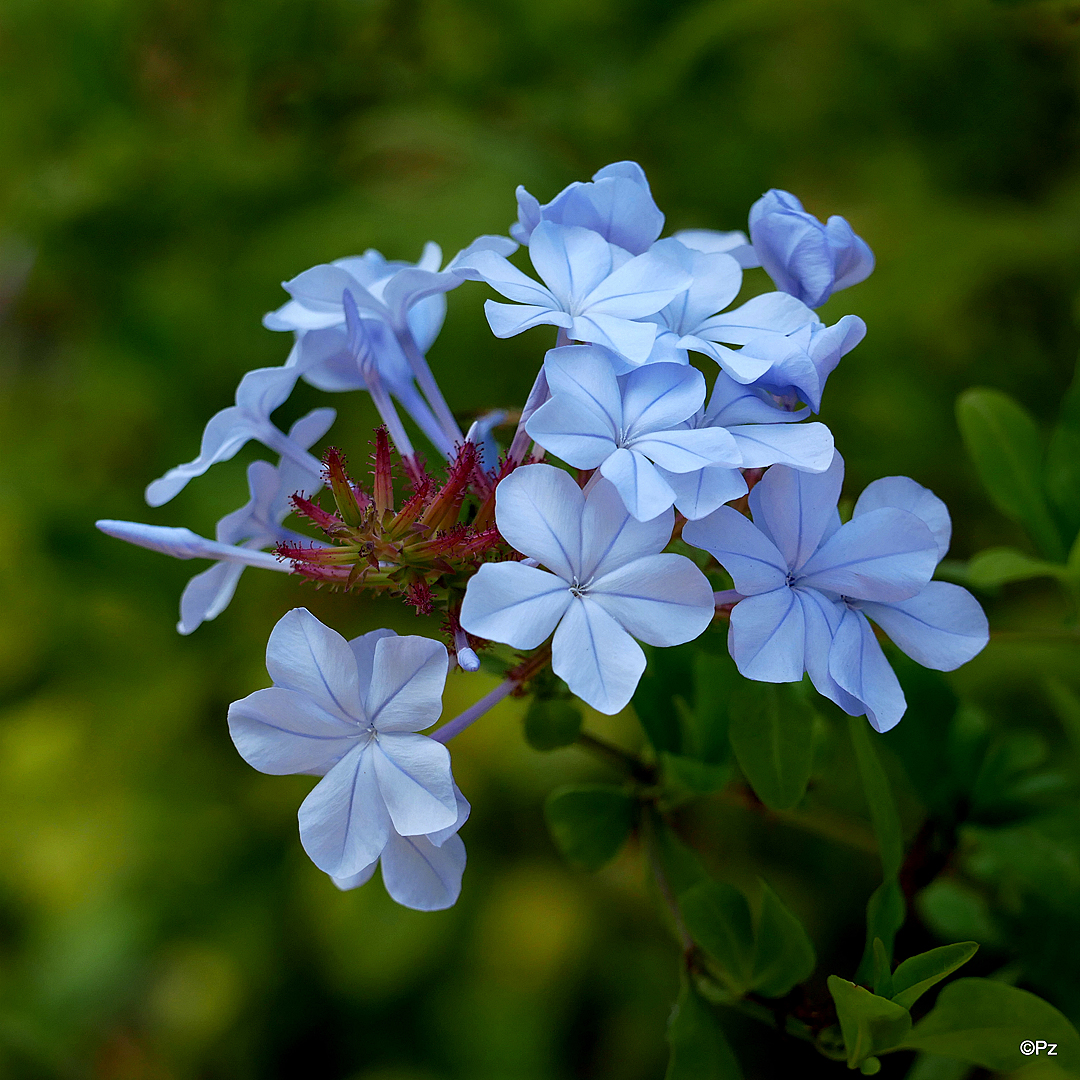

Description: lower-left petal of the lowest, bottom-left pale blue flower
[297,743,392,878]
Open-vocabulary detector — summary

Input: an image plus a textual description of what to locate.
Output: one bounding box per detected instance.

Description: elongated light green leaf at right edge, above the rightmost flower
[956,387,1065,563]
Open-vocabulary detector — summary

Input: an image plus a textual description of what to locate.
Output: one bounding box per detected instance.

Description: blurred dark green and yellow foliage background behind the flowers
[0,0,1080,1080]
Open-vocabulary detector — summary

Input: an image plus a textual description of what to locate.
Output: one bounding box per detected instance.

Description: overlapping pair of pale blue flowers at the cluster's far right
[683,455,989,731]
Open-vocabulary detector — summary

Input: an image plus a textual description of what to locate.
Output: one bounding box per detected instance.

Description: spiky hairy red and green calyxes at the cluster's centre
[276,428,513,623]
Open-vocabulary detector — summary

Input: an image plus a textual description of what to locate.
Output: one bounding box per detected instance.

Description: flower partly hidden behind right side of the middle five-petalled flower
[648,372,833,521]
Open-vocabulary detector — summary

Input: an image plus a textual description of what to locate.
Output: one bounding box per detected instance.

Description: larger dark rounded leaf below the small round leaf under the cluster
[543,784,634,870]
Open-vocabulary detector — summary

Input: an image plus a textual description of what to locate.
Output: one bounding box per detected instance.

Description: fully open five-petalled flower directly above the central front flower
[526,346,742,522]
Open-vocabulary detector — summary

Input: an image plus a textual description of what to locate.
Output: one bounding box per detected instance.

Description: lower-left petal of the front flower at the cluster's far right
[728,584,806,683]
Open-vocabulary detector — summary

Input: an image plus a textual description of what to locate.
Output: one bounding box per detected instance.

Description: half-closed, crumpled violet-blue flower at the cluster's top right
[750,188,874,308]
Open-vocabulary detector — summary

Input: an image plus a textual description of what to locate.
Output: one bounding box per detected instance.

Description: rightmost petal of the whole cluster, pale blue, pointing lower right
[860,581,990,672]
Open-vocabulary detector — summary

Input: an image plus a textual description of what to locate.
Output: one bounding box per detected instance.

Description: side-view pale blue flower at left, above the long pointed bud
[146,367,322,507]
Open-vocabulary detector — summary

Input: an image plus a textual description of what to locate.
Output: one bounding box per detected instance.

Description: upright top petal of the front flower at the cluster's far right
[750,454,843,569]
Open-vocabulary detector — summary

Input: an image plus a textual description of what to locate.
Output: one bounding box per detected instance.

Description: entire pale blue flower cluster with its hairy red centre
[98,162,987,909]
